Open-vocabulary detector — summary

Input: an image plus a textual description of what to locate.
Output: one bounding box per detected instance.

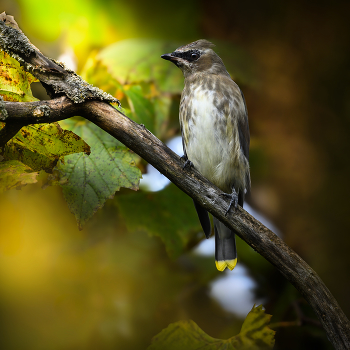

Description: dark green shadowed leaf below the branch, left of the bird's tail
[116,184,201,258]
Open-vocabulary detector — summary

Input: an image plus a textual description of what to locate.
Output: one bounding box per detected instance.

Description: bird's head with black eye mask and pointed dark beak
[161,39,229,78]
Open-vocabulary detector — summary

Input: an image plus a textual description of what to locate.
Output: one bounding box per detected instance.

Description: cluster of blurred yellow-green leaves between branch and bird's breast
[81,39,183,139]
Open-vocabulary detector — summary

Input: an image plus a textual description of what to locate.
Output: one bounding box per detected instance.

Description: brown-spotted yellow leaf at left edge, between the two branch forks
[0,50,38,102]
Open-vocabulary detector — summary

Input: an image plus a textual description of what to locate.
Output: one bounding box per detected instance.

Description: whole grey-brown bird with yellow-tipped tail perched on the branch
[161,39,251,271]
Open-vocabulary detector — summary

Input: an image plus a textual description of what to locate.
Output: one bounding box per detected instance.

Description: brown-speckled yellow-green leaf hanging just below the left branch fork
[3,123,90,173]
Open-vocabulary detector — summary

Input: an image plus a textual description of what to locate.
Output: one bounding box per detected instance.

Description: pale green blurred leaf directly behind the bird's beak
[97,39,183,94]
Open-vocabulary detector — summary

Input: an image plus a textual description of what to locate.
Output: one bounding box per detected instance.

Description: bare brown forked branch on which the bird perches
[0,13,350,349]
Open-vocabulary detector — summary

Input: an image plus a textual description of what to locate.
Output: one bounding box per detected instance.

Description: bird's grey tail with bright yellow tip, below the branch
[213,217,237,271]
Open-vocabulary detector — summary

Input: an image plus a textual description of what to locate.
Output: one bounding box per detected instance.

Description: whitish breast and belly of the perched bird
[186,89,245,192]
